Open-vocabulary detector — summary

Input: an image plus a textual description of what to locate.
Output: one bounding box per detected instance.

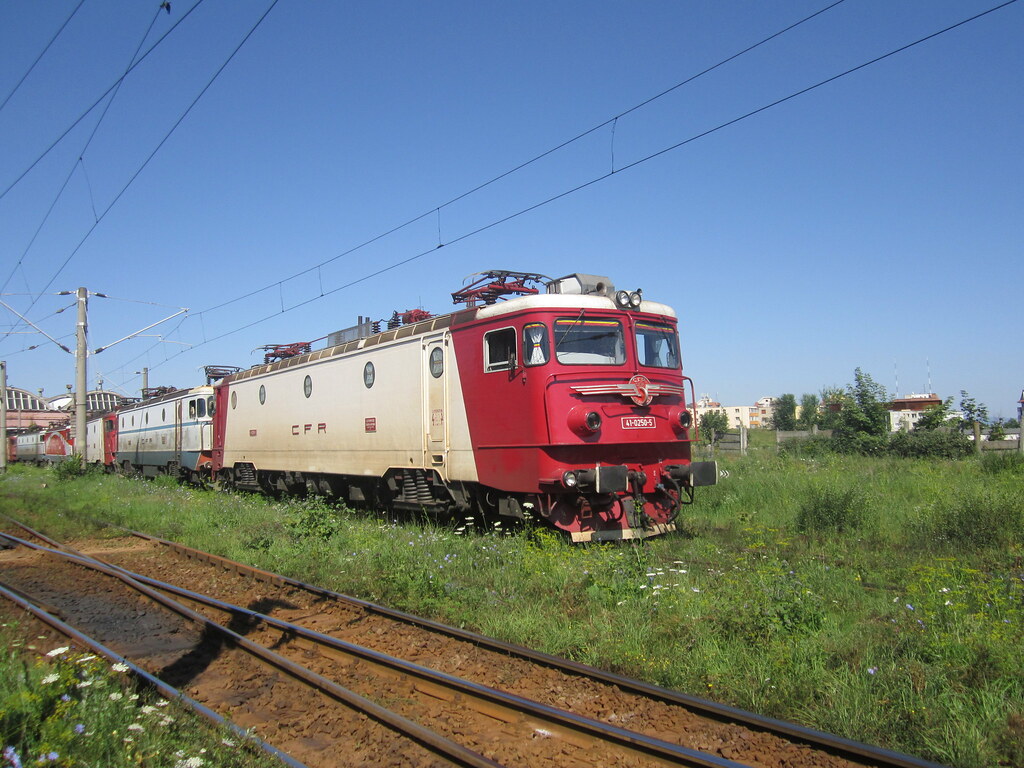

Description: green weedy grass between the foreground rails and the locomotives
[0,450,1024,768]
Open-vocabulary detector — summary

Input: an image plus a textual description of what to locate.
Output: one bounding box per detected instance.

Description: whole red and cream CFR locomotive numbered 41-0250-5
[212,271,718,541]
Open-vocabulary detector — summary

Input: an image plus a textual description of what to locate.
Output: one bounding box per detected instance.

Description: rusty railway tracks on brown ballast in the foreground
[0,523,934,768]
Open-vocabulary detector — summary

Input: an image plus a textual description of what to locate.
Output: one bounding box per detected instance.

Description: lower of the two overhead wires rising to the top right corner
[134,0,1017,376]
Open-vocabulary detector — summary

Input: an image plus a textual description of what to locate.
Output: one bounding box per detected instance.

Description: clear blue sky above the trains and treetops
[0,0,1024,417]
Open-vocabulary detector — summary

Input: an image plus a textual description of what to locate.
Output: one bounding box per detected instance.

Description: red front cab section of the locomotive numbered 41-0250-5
[452,275,717,541]
